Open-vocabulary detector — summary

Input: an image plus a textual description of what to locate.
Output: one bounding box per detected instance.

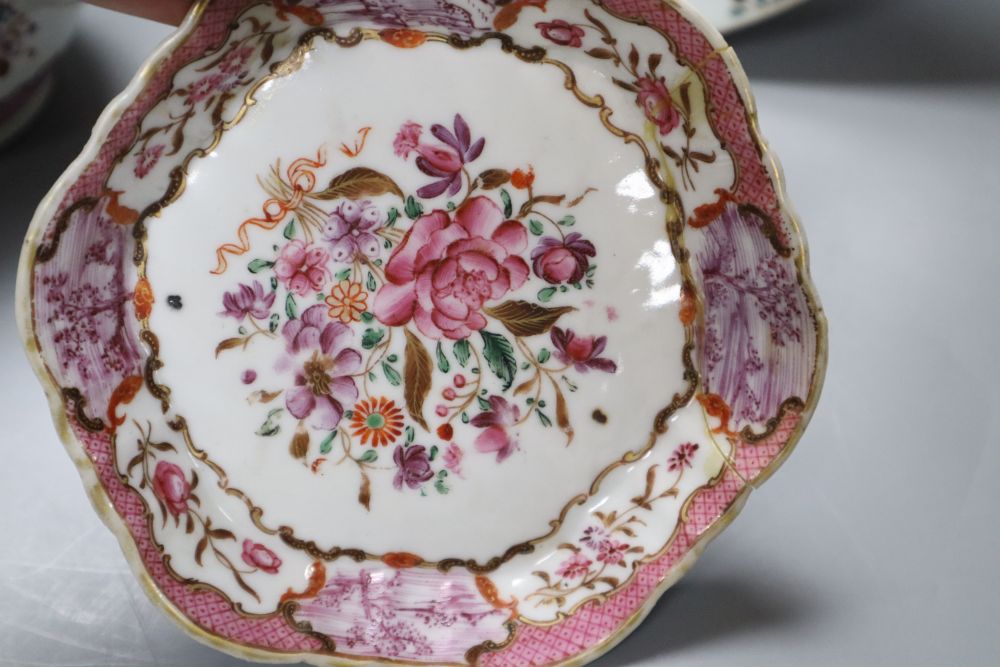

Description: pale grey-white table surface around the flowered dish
[0,0,1000,667]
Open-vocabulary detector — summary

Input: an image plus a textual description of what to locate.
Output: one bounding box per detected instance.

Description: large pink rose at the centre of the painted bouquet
[375,197,528,340]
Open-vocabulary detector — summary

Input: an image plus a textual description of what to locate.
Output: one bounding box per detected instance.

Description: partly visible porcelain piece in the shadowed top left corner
[0,0,77,143]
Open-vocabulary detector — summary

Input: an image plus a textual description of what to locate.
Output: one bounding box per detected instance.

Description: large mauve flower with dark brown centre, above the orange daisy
[281,305,362,431]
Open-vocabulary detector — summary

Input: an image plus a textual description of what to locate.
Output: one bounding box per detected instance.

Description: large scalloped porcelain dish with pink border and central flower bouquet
[18,0,826,666]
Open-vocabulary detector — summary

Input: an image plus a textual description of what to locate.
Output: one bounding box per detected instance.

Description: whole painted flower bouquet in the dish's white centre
[216,114,617,507]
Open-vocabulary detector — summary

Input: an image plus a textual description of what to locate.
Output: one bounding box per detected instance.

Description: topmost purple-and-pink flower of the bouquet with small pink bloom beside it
[393,114,486,199]
